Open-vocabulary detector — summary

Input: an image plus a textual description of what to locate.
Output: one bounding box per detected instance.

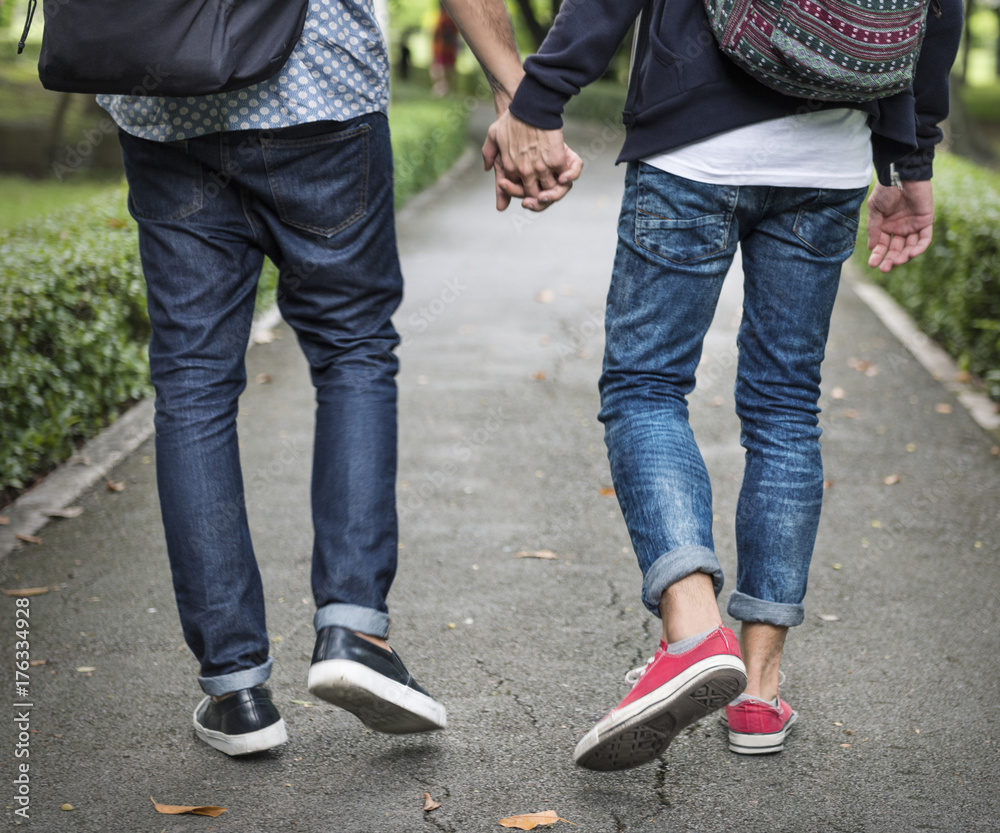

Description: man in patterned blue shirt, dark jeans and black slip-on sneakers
[100,0,580,755]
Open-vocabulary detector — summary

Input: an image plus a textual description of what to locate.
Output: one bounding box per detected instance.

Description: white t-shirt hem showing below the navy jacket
[643,108,872,188]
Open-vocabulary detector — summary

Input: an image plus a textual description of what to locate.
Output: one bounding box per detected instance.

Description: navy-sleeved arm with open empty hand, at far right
[868,0,963,272]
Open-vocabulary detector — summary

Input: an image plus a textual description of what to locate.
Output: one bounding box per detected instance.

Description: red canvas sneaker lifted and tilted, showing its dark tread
[573,625,747,771]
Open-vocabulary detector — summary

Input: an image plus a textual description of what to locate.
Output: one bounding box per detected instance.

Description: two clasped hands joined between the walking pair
[483,111,583,211]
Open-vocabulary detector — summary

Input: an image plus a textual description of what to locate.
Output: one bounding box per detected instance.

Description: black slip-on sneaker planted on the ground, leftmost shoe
[194,686,288,755]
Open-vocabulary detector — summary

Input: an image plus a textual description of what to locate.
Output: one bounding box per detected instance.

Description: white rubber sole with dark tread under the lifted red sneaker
[573,654,747,772]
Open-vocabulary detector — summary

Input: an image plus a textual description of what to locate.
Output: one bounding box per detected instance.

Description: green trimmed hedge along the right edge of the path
[858,155,1000,399]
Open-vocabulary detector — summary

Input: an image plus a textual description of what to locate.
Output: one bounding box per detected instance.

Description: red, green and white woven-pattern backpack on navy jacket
[704,0,940,101]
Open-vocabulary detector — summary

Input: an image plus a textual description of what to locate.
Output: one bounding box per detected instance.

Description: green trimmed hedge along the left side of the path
[0,99,470,503]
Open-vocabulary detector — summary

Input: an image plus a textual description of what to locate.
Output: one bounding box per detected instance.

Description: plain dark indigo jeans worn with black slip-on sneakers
[121,114,402,695]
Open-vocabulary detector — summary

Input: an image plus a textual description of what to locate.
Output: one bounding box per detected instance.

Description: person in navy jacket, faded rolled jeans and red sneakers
[484,0,962,770]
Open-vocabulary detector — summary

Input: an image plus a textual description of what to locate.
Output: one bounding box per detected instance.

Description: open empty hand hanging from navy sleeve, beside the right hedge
[868,180,934,272]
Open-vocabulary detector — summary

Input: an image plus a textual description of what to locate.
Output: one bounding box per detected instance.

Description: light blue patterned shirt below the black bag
[97,0,389,142]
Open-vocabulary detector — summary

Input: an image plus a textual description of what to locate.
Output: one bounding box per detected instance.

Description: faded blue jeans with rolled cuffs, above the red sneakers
[600,163,866,626]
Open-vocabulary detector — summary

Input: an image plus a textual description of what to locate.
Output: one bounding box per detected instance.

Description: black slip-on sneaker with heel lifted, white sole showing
[309,625,446,734]
